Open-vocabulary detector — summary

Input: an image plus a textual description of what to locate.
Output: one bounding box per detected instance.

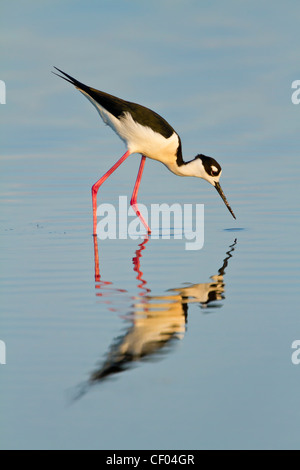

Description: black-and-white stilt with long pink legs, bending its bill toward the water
[53,67,235,235]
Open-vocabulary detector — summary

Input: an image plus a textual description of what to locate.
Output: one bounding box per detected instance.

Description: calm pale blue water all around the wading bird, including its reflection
[0,1,300,449]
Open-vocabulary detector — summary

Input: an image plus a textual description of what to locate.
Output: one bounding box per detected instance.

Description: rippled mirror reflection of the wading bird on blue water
[73,237,237,396]
